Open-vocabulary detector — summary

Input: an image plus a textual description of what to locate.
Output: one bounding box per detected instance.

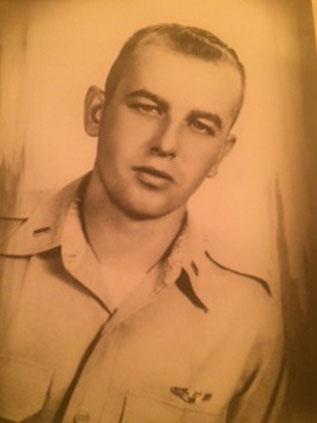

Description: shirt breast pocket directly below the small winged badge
[120,393,225,423]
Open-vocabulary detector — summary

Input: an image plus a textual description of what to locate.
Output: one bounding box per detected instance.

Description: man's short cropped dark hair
[105,24,246,121]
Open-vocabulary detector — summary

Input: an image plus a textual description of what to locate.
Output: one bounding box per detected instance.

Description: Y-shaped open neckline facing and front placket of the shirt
[58,200,202,423]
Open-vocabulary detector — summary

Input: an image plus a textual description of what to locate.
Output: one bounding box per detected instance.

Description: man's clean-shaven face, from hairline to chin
[88,45,241,218]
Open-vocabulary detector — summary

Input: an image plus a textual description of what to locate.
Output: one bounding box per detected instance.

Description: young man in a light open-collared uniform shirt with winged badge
[0,24,282,423]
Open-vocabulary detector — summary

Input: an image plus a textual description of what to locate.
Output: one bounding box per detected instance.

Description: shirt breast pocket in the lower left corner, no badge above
[0,355,52,422]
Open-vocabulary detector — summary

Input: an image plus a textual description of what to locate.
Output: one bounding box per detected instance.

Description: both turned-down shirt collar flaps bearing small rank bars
[0,174,211,311]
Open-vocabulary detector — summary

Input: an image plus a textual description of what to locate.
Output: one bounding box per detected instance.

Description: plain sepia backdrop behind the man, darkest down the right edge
[0,0,317,423]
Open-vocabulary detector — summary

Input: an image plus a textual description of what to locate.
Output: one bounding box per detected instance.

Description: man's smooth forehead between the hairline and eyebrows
[116,44,242,126]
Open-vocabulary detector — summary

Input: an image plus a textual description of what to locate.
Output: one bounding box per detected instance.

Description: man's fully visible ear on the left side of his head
[84,86,105,137]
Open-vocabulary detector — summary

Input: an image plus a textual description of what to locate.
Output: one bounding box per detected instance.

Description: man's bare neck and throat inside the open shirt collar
[83,174,185,273]
